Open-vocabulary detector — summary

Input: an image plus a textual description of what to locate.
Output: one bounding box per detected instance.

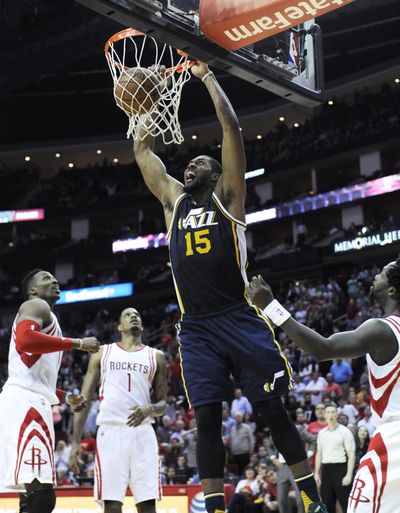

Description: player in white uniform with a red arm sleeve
[0,269,99,513]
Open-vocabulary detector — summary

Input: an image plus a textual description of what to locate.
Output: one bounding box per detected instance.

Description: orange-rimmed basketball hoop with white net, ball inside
[104,28,194,144]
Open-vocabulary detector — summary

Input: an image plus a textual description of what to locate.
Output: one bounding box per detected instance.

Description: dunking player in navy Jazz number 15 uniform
[134,63,326,513]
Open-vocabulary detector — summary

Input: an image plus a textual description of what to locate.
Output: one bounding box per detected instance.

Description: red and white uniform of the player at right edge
[347,315,400,513]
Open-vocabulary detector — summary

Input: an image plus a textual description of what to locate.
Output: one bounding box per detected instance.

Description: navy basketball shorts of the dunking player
[179,304,291,407]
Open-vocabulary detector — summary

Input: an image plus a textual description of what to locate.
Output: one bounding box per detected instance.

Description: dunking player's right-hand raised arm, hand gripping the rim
[192,62,246,221]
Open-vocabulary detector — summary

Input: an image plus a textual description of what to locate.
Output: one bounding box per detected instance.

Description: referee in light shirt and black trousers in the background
[315,404,355,513]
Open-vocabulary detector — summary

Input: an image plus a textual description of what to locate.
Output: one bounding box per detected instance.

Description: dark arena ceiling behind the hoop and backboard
[0,0,400,144]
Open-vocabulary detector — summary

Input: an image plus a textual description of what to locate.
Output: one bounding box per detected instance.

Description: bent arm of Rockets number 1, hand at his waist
[127,351,167,426]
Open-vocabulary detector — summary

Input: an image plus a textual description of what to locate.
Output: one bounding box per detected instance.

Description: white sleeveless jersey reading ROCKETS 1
[97,342,157,425]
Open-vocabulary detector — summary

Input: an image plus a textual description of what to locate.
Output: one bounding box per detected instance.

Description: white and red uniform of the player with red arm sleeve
[0,313,62,491]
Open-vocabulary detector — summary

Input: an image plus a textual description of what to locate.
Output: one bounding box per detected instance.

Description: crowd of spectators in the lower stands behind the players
[0,267,381,513]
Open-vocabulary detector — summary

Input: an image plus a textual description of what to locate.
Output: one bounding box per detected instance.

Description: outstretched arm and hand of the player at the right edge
[247,276,398,364]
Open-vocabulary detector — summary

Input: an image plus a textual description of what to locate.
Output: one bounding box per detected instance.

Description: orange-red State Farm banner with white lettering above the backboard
[200,0,354,50]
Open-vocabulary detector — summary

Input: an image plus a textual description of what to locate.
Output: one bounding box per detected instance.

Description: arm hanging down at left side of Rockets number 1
[69,350,102,474]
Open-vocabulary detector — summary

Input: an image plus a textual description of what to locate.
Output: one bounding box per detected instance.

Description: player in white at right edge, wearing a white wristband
[248,258,400,513]
